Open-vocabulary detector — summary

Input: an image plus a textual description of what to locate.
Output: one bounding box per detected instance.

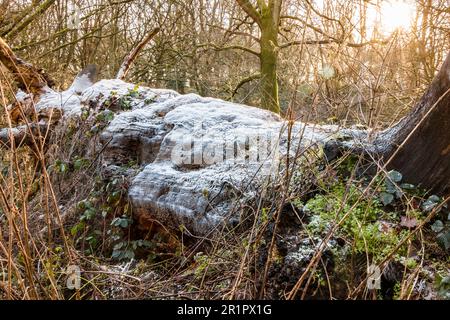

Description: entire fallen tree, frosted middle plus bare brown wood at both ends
[0,33,450,234]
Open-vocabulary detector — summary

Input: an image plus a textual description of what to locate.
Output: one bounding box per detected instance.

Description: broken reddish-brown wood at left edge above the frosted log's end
[0,38,53,96]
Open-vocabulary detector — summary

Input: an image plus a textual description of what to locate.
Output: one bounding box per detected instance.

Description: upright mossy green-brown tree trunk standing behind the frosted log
[260,11,280,113]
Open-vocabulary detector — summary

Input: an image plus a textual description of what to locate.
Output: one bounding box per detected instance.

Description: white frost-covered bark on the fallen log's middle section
[6,79,367,235]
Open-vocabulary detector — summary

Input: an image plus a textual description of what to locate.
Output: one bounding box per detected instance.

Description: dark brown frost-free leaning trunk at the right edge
[388,53,450,195]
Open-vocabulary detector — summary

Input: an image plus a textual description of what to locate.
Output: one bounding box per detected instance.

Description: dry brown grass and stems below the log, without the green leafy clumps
[0,73,446,299]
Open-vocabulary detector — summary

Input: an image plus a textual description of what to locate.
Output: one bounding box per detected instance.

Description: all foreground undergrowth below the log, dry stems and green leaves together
[0,82,450,299]
